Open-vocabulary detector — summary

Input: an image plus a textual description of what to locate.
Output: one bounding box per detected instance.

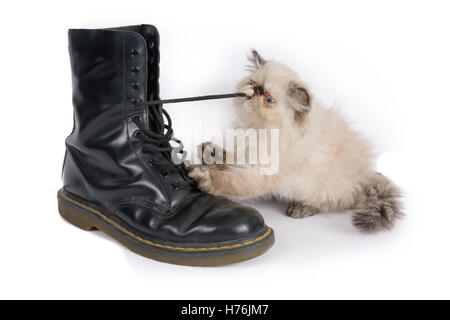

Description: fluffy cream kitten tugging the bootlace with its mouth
[190,51,402,232]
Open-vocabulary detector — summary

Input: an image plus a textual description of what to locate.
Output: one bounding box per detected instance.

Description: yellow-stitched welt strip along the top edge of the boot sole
[59,191,272,251]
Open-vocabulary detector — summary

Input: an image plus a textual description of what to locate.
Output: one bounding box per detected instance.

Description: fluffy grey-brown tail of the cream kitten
[353,173,404,232]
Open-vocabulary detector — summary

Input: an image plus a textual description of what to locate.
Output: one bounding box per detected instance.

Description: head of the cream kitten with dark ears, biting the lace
[237,51,311,125]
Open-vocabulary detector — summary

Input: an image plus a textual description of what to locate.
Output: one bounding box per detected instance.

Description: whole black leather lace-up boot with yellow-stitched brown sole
[58,25,274,265]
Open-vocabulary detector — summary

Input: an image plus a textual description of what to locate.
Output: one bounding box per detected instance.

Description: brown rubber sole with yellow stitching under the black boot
[58,189,275,266]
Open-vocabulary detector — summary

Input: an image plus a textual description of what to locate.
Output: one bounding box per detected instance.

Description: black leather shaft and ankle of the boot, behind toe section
[63,25,188,211]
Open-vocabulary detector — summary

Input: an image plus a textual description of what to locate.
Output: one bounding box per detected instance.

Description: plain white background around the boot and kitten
[0,0,450,299]
